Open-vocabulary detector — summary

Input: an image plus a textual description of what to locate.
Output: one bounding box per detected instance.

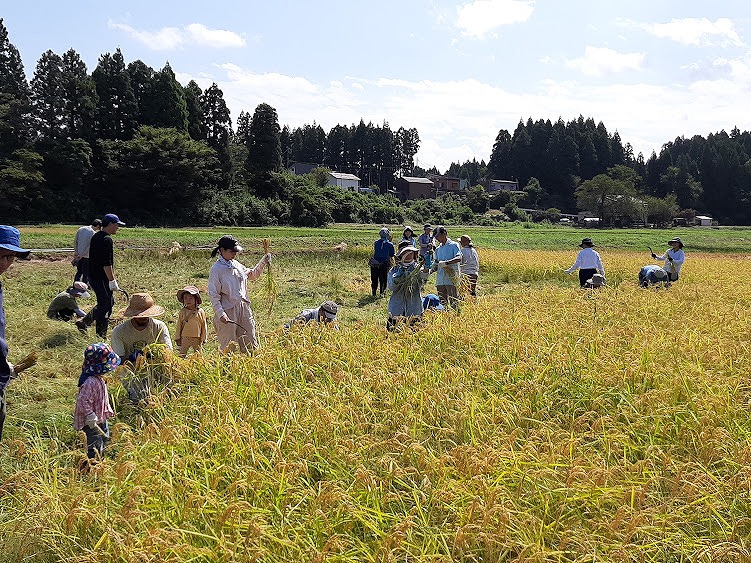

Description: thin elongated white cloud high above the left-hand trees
[108,22,245,51]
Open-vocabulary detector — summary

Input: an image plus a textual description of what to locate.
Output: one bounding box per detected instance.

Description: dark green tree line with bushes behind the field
[0,19,751,225]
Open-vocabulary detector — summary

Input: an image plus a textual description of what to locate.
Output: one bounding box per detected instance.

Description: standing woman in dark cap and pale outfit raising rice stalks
[209,235,270,352]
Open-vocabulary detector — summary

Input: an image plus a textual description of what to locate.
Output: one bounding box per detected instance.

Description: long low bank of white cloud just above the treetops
[179,55,751,171]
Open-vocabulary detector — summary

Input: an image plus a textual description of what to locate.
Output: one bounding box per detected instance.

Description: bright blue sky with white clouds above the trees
[0,0,751,171]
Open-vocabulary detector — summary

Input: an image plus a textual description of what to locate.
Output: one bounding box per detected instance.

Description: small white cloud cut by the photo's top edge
[456,0,535,39]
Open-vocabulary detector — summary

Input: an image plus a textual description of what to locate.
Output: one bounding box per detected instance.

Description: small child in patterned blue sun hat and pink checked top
[73,342,120,459]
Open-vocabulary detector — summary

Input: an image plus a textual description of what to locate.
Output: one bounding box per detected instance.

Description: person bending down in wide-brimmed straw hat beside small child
[112,293,172,361]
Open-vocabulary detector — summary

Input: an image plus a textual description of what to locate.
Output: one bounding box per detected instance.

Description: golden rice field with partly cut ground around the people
[0,227,751,562]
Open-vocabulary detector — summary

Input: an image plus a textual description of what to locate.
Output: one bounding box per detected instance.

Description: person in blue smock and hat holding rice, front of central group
[386,246,423,330]
